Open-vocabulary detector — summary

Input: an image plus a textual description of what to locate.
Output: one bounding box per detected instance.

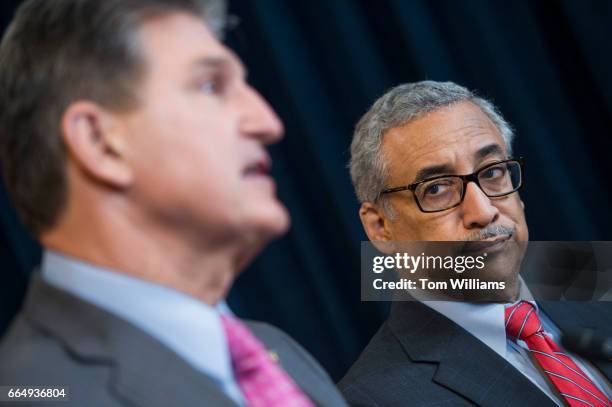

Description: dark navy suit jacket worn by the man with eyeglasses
[339,302,612,407]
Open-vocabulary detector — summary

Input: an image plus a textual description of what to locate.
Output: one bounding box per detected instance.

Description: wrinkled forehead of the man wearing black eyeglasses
[382,102,507,182]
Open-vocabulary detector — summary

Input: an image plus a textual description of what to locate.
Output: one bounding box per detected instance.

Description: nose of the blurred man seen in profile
[240,85,284,144]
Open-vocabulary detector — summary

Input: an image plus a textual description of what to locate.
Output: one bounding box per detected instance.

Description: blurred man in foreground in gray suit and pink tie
[0,0,344,406]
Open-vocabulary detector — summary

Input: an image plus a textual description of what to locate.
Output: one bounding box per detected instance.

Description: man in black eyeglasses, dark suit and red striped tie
[340,81,612,406]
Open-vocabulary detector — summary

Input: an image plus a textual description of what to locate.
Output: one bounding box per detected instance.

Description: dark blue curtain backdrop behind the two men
[0,0,612,379]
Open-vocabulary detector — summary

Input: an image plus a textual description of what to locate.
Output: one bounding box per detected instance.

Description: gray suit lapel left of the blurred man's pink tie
[24,275,236,407]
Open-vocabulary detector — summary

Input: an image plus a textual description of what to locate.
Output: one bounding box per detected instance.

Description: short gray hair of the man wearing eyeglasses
[349,81,514,215]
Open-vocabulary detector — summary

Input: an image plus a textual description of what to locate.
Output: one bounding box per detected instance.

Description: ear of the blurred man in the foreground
[60,101,133,189]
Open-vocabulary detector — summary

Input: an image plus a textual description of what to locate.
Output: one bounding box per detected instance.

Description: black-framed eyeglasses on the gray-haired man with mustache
[380,158,524,212]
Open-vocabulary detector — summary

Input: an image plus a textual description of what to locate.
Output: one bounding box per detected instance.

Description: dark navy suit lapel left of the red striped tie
[389,302,554,406]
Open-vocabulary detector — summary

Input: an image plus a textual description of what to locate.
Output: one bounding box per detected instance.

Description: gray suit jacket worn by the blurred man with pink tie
[0,275,346,407]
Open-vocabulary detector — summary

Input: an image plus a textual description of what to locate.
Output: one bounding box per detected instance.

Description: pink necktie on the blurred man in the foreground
[221,315,314,407]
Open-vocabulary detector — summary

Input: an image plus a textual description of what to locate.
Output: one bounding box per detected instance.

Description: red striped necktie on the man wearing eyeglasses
[506,301,612,407]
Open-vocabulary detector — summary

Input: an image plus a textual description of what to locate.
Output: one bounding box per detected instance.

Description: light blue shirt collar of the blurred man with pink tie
[41,250,244,405]
